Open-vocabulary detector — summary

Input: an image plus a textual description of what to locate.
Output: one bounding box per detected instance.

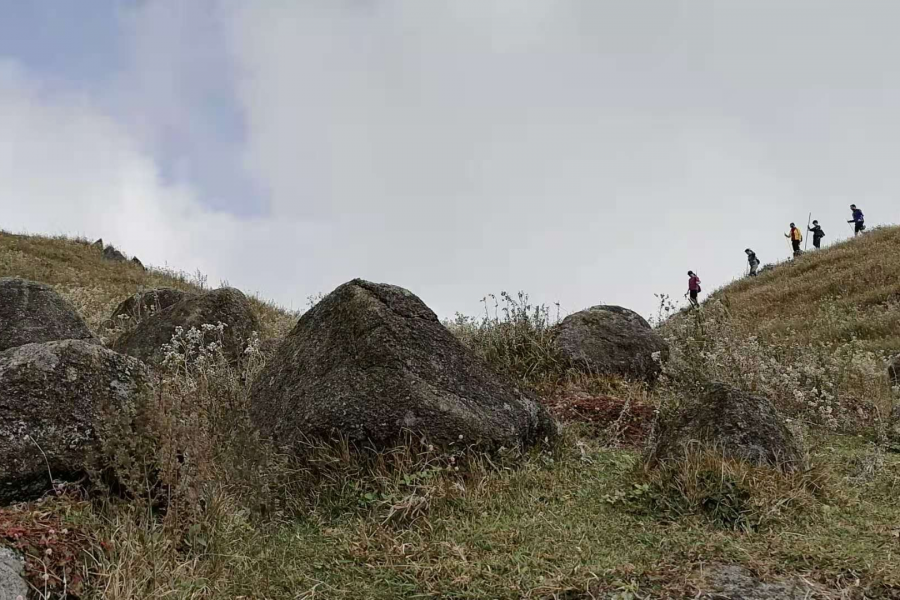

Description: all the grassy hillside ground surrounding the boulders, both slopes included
[0,229,900,600]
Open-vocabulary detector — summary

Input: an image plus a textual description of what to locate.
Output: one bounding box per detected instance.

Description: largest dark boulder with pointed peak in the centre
[250,279,556,447]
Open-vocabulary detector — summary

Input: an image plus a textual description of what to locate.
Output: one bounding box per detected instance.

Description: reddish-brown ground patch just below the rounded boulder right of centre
[545,392,654,446]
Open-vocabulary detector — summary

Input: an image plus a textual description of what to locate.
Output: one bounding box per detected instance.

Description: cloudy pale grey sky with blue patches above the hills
[0,0,900,317]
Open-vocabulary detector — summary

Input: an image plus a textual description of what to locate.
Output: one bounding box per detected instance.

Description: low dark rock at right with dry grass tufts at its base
[650,384,804,470]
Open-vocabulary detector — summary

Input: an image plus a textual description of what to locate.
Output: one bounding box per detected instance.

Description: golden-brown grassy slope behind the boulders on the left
[0,231,296,339]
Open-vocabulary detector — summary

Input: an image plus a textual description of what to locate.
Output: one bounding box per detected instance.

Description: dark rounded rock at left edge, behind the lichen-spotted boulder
[0,277,99,351]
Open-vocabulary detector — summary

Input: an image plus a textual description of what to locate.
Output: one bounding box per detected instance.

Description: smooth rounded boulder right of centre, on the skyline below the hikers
[554,306,669,382]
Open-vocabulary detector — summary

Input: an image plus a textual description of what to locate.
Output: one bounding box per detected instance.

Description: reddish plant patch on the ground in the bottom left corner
[0,498,89,598]
